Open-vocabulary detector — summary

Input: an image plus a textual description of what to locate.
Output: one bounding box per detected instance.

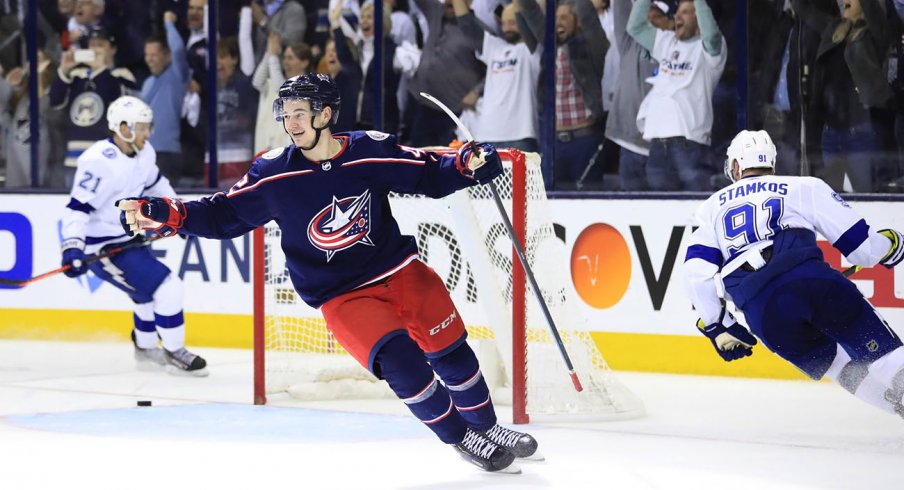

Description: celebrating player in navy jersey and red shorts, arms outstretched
[119,74,537,472]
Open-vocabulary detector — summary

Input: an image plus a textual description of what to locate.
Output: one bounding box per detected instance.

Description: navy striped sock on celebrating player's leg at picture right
[430,342,496,432]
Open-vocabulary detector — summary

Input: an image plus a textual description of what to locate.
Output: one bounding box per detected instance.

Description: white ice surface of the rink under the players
[0,341,904,490]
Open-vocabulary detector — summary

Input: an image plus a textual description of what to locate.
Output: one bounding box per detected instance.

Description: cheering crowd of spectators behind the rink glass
[0,0,904,192]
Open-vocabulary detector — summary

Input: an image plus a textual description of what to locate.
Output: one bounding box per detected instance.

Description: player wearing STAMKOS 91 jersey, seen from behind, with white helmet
[684,131,904,417]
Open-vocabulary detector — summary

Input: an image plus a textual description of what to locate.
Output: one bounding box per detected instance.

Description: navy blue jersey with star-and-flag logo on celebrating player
[180,131,476,308]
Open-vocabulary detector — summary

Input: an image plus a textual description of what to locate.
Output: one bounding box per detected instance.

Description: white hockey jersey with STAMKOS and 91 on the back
[683,175,891,325]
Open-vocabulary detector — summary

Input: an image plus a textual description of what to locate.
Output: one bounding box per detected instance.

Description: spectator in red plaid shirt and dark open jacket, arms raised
[520,0,609,188]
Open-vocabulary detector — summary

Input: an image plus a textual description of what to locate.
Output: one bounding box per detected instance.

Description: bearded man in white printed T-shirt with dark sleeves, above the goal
[456,0,541,151]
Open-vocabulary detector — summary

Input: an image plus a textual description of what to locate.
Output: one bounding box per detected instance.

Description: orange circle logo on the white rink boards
[571,223,631,309]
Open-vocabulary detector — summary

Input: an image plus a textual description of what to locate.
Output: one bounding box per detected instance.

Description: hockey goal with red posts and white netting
[254,150,643,423]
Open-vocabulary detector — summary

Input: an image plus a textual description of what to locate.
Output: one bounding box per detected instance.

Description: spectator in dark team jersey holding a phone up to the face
[50,26,137,187]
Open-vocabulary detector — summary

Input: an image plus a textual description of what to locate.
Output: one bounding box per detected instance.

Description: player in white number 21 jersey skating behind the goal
[62,96,207,376]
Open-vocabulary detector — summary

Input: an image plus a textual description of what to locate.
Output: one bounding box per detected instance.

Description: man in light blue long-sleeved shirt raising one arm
[141,11,191,186]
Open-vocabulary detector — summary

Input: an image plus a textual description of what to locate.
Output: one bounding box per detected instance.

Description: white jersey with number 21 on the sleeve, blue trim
[62,139,176,254]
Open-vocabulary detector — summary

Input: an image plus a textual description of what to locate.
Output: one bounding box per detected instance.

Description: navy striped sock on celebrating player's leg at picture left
[374,335,467,444]
